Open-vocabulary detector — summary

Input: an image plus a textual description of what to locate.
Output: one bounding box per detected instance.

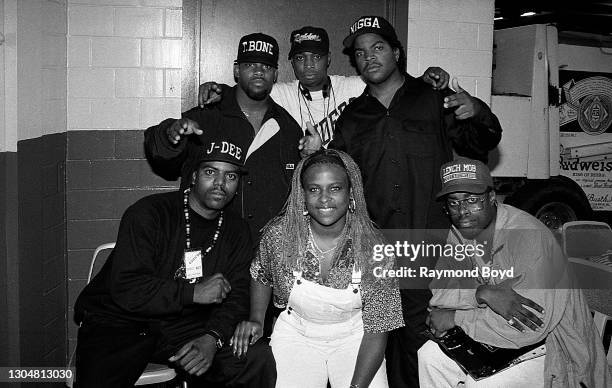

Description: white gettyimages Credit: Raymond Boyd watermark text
[372,241,514,281]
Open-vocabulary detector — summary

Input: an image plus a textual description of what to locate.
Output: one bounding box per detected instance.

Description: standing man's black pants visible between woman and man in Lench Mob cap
[385,289,431,388]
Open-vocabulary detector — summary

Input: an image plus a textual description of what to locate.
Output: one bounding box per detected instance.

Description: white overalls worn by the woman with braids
[270,268,388,388]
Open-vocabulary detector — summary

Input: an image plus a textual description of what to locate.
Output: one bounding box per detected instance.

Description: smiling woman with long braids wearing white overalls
[231,150,404,388]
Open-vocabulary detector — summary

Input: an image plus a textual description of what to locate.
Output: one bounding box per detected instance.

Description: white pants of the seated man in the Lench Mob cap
[418,341,546,388]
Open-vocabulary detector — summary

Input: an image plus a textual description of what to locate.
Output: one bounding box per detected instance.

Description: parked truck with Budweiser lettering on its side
[490,24,612,229]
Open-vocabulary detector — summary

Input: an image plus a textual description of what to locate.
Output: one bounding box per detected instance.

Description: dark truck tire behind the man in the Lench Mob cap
[505,177,593,232]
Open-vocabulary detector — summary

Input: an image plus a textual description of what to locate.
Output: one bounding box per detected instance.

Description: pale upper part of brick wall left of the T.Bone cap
[68,0,182,131]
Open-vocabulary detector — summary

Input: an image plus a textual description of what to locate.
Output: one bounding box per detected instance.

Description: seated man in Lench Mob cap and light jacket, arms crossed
[418,158,612,388]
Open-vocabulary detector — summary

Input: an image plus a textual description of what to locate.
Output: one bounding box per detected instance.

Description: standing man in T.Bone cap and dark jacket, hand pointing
[145,33,302,241]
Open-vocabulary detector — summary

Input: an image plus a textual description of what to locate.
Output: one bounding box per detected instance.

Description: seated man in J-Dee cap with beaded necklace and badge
[75,139,276,388]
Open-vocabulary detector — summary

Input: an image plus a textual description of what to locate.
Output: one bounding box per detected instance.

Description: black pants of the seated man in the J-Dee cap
[75,316,276,388]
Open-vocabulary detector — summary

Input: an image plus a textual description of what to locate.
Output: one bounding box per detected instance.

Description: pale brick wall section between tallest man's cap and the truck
[406,0,495,104]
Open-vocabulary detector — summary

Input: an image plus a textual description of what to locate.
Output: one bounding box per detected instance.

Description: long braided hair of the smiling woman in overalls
[264,149,383,270]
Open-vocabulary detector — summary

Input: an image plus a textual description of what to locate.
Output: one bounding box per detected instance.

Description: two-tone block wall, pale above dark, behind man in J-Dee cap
[66,0,182,358]
